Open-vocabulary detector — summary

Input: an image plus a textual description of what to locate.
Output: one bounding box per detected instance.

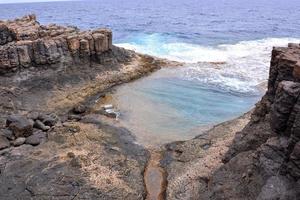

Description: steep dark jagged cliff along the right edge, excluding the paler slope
[206,44,300,200]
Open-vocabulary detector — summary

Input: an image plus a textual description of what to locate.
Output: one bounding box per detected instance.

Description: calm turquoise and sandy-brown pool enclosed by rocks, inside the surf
[112,64,262,146]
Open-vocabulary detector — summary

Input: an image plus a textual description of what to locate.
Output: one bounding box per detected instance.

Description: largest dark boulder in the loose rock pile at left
[6,115,33,137]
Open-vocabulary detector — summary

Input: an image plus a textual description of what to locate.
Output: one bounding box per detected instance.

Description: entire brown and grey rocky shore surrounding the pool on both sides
[0,15,300,200]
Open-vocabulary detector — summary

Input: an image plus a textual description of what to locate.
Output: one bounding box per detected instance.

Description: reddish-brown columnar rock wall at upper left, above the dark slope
[0,15,112,75]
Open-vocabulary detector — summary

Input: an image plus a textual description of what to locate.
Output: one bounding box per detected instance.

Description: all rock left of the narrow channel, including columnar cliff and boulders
[0,15,178,200]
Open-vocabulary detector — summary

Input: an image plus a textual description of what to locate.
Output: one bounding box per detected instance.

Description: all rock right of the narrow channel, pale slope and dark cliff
[162,44,300,200]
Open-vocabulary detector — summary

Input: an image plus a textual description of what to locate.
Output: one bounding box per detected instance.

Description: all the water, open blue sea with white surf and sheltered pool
[0,0,300,143]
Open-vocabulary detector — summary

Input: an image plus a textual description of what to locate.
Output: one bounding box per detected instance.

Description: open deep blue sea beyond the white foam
[0,0,300,45]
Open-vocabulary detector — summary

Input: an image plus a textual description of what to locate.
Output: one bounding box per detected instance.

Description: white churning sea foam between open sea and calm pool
[117,34,300,93]
